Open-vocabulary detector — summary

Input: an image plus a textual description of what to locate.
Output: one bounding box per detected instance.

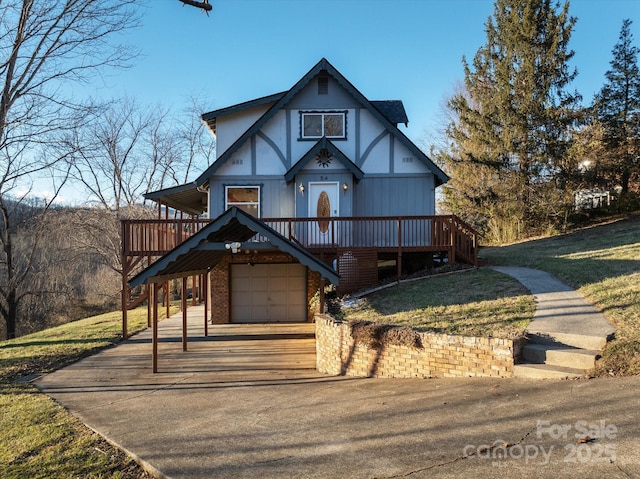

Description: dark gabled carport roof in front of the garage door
[129,207,339,287]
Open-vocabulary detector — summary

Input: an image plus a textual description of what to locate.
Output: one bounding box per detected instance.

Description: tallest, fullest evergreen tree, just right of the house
[443,0,580,241]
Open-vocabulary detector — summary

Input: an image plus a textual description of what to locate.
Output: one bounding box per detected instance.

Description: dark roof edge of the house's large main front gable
[195,58,449,186]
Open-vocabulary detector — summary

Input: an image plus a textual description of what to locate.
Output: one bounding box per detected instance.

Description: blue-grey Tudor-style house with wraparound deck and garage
[123,59,477,330]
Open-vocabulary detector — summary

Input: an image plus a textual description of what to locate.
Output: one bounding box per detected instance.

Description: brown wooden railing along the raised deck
[122,215,478,264]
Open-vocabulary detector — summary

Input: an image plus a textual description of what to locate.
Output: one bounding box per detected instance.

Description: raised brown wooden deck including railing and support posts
[121,215,478,338]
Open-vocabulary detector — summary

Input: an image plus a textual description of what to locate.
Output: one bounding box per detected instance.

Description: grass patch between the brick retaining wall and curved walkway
[343,269,535,338]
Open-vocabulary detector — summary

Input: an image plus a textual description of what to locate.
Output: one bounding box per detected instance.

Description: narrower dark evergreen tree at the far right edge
[594,20,640,194]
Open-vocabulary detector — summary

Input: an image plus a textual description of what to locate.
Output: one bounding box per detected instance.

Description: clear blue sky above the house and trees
[104,0,640,147]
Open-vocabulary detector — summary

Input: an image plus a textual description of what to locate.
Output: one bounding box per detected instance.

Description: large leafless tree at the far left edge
[0,0,137,338]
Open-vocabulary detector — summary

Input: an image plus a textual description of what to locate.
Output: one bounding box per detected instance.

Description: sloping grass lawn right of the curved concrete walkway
[480,216,640,375]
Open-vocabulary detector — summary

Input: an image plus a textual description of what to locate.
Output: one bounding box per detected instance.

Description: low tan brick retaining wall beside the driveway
[315,315,521,378]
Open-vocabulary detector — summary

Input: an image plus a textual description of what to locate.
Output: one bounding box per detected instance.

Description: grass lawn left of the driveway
[0,307,177,479]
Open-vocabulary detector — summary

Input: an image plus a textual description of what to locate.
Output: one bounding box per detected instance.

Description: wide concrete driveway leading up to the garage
[37,308,640,478]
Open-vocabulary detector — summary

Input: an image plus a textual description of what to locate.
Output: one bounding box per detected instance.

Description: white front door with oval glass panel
[309,181,340,245]
